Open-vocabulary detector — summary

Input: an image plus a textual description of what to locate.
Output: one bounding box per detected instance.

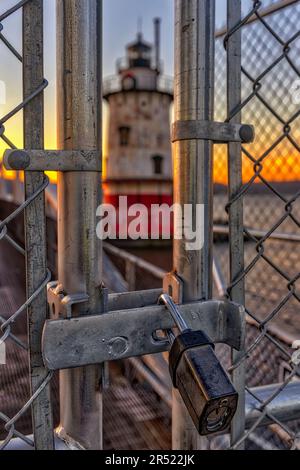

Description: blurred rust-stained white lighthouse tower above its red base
[104,18,173,239]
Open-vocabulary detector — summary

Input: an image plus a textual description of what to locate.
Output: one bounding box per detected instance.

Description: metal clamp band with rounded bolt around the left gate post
[4,150,102,172]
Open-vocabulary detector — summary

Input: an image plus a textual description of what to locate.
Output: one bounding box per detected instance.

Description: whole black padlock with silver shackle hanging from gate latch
[160,294,238,436]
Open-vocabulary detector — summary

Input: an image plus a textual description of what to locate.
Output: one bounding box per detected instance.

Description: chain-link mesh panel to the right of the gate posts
[215,1,300,449]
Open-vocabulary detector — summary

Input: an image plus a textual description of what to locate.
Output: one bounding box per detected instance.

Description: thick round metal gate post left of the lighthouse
[57,0,102,450]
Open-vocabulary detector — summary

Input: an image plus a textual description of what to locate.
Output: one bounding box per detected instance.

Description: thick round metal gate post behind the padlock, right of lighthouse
[173,0,215,450]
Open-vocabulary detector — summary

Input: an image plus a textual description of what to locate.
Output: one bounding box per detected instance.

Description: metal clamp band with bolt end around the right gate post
[172,121,255,144]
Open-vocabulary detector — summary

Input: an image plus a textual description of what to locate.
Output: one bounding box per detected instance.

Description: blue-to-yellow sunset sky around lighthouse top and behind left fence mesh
[0,0,296,184]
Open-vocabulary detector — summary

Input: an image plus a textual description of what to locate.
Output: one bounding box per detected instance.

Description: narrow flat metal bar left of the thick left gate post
[23,0,54,450]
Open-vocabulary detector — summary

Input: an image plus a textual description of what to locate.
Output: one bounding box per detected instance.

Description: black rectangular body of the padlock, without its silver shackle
[175,345,238,436]
